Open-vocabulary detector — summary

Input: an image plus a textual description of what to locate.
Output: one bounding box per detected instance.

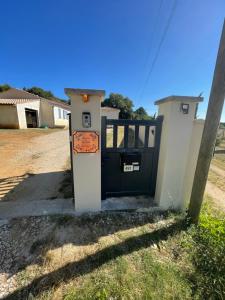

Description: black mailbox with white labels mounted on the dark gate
[120,152,141,172]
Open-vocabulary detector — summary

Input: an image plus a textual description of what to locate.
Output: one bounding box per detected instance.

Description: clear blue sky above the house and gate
[0,0,225,121]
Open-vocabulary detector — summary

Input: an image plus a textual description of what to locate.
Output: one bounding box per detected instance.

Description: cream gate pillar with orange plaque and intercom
[65,88,105,212]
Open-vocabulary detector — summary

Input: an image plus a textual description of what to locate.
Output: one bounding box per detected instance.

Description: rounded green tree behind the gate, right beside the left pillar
[102,93,134,119]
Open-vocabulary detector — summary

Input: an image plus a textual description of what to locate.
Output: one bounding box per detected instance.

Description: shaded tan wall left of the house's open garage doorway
[0,104,19,129]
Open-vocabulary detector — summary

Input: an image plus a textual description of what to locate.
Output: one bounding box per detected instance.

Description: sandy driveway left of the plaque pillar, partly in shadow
[0,130,69,201]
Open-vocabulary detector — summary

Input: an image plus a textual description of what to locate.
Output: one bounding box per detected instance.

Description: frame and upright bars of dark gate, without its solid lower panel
[101,116,163,200]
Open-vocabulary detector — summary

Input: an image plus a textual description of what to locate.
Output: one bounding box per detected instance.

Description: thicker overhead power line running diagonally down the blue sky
[140,0,177,99]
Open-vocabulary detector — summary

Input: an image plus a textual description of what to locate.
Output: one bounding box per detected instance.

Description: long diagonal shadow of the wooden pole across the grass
[4,221,186,299]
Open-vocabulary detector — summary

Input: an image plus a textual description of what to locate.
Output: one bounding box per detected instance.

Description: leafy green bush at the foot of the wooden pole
[190,203,225,299]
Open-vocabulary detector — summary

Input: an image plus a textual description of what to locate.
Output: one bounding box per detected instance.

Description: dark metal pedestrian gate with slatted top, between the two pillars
[101,116,163,200]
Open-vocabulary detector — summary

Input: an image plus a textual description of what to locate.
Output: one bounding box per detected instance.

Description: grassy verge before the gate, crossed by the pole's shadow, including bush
[7,199,225,300]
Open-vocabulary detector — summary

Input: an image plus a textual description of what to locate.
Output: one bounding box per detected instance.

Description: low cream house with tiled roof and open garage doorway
[0,88,70,129]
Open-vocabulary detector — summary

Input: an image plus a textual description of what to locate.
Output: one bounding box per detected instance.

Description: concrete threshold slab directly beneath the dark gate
[102,196,154,211]
